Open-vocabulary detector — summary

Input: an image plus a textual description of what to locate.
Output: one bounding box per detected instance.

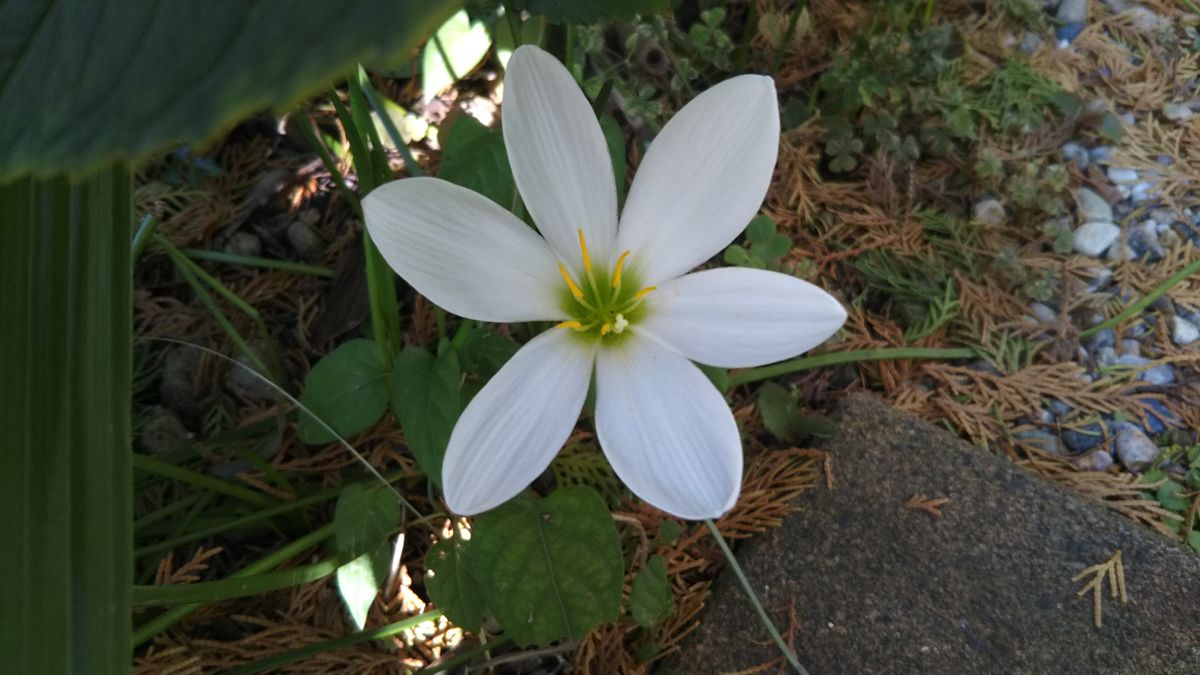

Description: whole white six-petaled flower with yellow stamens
[362,46,846,519]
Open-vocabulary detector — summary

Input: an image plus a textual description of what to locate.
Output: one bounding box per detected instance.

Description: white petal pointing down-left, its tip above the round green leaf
[442,329,595,515]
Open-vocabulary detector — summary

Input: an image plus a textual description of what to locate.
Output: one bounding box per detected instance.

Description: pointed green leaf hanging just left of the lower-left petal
[391,348,462,485]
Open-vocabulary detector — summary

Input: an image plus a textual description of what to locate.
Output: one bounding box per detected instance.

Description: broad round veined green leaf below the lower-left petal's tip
[468,485,624,645]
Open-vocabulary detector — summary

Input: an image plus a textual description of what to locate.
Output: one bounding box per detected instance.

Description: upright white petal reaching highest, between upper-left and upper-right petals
[500,44,617,270]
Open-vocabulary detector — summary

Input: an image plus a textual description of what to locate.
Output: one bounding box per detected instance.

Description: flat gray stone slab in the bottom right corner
[659,395,1200,675]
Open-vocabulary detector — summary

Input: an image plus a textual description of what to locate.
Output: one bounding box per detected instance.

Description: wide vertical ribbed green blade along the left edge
[0,165,133,673]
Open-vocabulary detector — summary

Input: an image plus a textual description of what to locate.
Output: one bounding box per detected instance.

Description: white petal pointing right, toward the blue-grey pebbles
[638,267,846,368]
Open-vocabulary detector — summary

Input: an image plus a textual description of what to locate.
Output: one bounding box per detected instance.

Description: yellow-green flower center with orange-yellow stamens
[558,229,654,340]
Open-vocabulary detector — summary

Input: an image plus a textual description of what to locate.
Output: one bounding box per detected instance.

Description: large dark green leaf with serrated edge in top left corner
[0,0,462,175]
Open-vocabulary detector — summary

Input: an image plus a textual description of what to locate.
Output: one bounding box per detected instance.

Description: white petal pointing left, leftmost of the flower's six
[362,178,565,323]
